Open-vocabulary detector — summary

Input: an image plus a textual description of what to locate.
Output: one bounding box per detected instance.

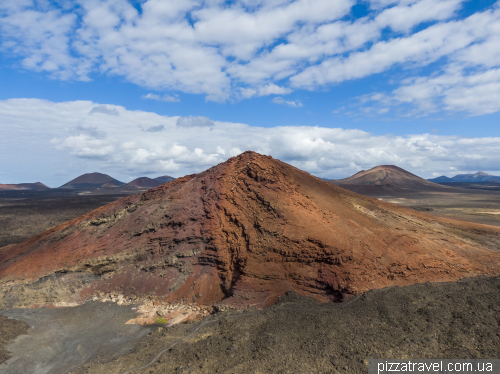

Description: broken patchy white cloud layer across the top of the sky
[0,0,500,115]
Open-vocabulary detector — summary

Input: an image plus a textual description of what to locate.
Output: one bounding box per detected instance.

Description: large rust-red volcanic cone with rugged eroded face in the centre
[0,152,500,306]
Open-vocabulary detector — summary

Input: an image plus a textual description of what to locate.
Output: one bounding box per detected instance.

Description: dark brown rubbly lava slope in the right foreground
[69,277,500,374]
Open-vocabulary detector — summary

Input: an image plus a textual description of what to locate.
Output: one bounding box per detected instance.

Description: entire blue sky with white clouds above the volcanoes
[0,0,500,187]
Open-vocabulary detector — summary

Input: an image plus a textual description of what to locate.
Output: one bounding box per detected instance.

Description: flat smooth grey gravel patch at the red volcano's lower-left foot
[0,302,155,374]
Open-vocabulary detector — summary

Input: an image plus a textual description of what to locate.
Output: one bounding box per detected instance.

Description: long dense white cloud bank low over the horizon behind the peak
[0,99,500,185]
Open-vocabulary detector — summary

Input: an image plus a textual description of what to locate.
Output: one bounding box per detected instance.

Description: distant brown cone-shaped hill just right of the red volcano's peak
[329,165,456,194]
